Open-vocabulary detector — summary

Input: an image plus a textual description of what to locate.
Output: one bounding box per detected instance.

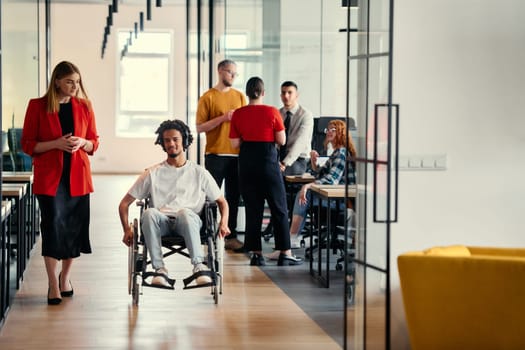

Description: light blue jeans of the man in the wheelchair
[142,208,204,270]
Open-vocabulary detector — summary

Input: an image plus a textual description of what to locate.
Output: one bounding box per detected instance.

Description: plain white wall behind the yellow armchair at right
[391,0,525,349]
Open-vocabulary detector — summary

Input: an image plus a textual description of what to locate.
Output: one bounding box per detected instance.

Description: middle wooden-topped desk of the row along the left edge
[2,183,29,289]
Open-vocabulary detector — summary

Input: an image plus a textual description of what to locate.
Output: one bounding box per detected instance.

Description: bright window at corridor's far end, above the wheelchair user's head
[115,31,173,137]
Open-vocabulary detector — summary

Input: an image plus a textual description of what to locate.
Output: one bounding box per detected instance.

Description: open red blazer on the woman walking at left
[21,97,98,196]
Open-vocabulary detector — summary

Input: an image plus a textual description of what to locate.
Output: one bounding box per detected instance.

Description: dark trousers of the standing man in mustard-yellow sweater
[204,154,241,239]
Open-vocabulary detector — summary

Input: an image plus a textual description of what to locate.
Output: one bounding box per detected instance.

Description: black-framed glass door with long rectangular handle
[343,0,398,349]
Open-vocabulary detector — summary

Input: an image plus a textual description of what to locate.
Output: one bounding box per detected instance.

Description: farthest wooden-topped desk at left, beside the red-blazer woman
[2,171,36,249]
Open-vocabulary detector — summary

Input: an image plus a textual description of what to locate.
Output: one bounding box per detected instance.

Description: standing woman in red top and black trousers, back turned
[230,77,303,266]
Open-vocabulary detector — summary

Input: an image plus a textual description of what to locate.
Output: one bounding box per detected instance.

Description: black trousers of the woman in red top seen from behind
[239,142,290,251]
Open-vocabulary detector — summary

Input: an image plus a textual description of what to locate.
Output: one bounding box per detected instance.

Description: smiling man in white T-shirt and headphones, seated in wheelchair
[119,120,230,288]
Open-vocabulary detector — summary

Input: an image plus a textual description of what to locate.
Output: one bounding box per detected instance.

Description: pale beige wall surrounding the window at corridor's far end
[51,2,186,173]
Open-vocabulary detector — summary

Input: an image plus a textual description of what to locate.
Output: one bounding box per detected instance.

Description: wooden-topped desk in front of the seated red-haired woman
[310,184,357,288]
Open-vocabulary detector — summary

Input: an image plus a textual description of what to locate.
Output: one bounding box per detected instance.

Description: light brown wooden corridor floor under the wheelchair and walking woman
[0,175,340,350]
